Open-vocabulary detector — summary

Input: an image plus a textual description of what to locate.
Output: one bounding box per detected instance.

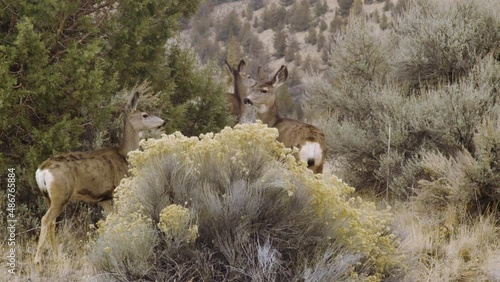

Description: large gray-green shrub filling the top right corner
[393,0,500,88]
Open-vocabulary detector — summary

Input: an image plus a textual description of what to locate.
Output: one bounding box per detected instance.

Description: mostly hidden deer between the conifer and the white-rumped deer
[224,60,255,123]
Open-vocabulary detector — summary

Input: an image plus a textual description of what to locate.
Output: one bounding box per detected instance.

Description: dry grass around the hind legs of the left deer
[0,204,98,282]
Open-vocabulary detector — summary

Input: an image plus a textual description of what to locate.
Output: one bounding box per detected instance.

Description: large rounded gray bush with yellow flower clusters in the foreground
[90,124,398,281]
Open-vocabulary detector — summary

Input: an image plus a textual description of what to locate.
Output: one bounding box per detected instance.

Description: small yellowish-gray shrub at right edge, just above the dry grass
[415,114,500,224]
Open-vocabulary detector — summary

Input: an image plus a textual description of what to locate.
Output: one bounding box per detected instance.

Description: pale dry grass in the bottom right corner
[395,205,500,281]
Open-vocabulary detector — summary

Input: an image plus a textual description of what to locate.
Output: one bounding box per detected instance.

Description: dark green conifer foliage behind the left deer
[0,0,230,225]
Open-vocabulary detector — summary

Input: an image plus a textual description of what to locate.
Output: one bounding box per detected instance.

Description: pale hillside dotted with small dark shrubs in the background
[181,0,406,76]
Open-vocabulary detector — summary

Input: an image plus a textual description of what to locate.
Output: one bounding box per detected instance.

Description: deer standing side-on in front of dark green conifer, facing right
[35,86,165,268]
